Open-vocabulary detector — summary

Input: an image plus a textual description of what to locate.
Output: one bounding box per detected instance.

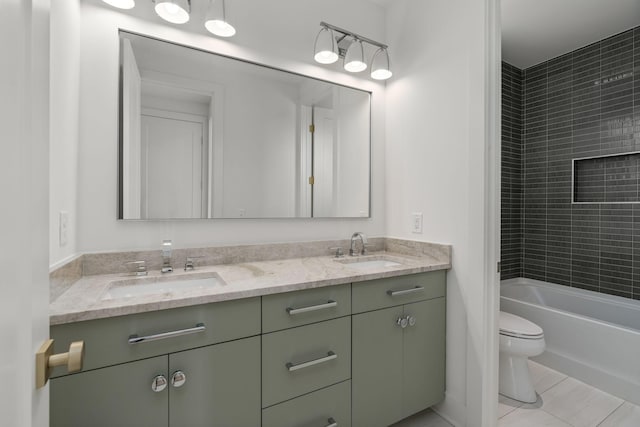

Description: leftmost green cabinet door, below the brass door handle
[50,356,169,427]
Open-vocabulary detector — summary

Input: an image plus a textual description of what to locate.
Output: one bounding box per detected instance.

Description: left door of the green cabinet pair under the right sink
[351,307,402,427]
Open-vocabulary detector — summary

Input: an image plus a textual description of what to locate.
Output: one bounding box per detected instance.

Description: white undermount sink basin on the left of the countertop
[102,273,226,300]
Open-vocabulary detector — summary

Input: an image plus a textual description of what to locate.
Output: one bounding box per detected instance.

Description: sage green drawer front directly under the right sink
[352,270,446,313]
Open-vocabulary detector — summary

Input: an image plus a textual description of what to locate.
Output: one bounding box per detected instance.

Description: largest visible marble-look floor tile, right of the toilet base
[536,378,624,427]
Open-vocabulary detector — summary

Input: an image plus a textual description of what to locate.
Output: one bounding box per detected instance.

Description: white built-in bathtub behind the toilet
[500,278,640,405]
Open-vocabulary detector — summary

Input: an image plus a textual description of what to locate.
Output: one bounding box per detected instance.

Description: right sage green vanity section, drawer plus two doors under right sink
[352,272,445,427]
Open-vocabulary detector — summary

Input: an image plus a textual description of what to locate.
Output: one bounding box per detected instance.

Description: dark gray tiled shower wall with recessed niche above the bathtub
[502,27,640,299]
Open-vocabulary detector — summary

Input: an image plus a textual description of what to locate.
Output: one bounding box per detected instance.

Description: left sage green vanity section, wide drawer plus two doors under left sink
[50,298,261,427]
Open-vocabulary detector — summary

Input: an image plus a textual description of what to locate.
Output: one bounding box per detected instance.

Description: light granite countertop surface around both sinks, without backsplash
[50,251,451,326]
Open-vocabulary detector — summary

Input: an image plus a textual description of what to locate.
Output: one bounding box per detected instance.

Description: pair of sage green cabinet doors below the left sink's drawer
[51,336,261,427]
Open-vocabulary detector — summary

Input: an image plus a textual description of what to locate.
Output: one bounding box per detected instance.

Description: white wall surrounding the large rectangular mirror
[77,0,385,252]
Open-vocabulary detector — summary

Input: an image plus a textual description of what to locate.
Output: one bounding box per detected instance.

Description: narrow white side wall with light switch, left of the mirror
[49,0,80,264]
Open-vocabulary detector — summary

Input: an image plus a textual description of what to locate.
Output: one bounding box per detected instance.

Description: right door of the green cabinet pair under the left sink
[169,337,261,427]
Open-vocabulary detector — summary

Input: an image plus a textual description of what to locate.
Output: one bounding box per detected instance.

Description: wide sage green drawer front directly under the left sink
[51,298,260,376]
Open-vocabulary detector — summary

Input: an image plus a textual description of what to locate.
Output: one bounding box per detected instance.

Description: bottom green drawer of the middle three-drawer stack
[262,381,351,427]
